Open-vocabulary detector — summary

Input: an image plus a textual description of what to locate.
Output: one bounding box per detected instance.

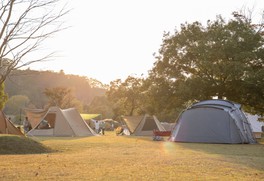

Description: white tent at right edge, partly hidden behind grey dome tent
[246,113,264,138]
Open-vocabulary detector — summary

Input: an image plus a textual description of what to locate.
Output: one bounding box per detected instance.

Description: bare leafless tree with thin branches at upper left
[0,0,69,84]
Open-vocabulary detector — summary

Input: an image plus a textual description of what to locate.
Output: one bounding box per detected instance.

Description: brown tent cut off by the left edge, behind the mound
[0,111,24,136]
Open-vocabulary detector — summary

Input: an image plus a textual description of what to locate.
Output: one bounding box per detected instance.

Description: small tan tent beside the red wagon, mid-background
[123,115,165,136]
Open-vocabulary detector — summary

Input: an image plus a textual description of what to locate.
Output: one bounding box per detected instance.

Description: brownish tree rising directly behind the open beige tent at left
[44,87,82,112]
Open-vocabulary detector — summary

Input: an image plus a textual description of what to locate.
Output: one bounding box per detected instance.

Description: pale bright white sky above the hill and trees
[30,0,264,84]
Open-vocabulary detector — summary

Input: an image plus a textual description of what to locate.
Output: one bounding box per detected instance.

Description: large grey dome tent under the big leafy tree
[169,100,256,143]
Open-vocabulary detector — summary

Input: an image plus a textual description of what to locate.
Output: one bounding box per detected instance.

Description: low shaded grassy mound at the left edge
[0,135,55,155]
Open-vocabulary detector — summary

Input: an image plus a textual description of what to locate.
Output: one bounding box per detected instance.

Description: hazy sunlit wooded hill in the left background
[5,69,106,108]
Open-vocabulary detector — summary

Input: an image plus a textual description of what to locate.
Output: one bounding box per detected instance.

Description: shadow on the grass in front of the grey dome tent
[171,138,264,171]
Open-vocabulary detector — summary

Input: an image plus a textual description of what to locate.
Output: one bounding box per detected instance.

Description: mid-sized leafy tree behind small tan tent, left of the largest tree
[106,76,143,116]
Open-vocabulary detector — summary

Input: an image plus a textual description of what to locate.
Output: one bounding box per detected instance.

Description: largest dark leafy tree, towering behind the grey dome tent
[148,13,264,112]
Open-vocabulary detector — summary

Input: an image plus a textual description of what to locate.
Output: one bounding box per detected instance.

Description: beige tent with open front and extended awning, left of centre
[26,107,95,136]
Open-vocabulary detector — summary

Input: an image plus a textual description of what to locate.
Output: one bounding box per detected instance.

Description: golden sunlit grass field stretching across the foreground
[0,132,264,181]
